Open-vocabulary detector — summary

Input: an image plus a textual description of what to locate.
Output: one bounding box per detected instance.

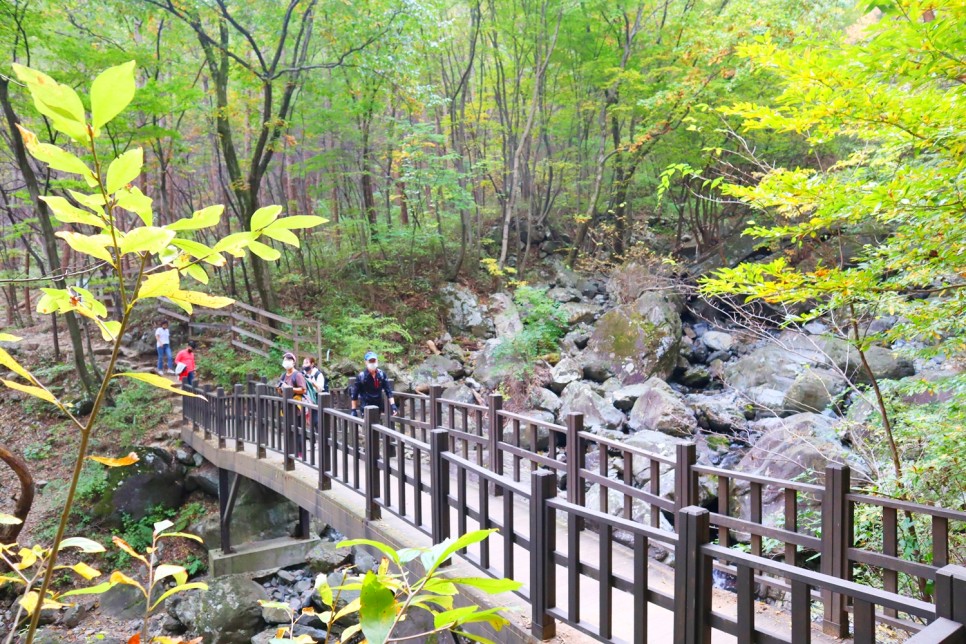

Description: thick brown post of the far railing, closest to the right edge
[820,463,852,637]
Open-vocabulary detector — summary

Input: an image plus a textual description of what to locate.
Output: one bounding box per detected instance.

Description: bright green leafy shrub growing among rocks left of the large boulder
[495,286,567,375]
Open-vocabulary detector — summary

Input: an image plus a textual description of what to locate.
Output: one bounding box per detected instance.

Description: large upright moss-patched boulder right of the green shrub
[581,291,681,384]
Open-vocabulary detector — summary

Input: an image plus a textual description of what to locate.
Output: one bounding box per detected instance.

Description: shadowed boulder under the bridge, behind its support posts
[187,478,298,549]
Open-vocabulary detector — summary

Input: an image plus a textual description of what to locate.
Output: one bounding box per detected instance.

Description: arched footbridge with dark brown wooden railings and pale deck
[183,381,966,644]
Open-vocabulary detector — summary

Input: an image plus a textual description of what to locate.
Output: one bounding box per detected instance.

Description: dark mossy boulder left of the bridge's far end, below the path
[92,447,185,527]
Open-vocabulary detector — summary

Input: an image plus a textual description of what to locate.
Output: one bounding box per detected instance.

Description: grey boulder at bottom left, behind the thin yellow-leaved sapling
[168,575,271,644]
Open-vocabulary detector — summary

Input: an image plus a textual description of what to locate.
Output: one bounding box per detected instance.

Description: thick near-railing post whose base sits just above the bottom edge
[530,470,560,641]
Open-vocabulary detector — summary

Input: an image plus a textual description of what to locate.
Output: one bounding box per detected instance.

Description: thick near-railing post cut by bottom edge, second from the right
[674,506,711,644]
